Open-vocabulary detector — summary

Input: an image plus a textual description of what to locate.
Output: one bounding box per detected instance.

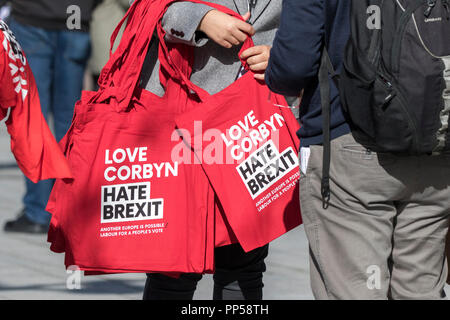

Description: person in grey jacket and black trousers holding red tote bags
[131,0,281,300]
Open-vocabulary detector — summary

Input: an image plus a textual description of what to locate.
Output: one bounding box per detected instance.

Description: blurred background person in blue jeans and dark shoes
[4,0,100,233]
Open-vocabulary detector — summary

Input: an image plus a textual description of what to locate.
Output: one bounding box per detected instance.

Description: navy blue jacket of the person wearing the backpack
[265,0,350,147]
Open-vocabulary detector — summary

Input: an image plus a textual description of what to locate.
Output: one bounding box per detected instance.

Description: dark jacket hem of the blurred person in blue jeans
[12,0,101,31]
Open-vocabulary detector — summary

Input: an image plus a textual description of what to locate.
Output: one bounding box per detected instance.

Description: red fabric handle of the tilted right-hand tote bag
[157,0,254,101]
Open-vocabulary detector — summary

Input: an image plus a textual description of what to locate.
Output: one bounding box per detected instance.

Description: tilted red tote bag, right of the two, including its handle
[162,3,302,251]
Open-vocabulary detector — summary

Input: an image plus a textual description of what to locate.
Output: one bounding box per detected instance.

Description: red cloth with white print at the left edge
[0,20,72,182]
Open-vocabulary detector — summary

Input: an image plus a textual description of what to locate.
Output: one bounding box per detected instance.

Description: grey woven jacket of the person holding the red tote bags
[135,0,281,96]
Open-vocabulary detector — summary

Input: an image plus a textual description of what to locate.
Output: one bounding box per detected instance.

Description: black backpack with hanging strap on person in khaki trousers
[319,0,450,205]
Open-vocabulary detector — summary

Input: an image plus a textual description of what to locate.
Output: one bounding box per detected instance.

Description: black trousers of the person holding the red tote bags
[143,244,269,300]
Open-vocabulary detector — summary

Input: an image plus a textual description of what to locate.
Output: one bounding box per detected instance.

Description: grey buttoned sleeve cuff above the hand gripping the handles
[162,2,213,46]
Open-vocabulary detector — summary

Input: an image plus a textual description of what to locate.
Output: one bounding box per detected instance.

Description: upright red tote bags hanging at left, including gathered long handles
[47,0,214,274]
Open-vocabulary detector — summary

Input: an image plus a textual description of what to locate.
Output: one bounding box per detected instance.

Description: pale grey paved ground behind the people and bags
[0,123,312,300]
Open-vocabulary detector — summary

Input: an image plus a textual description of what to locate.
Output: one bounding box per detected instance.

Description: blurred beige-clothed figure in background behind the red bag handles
[88,0,130,90]
